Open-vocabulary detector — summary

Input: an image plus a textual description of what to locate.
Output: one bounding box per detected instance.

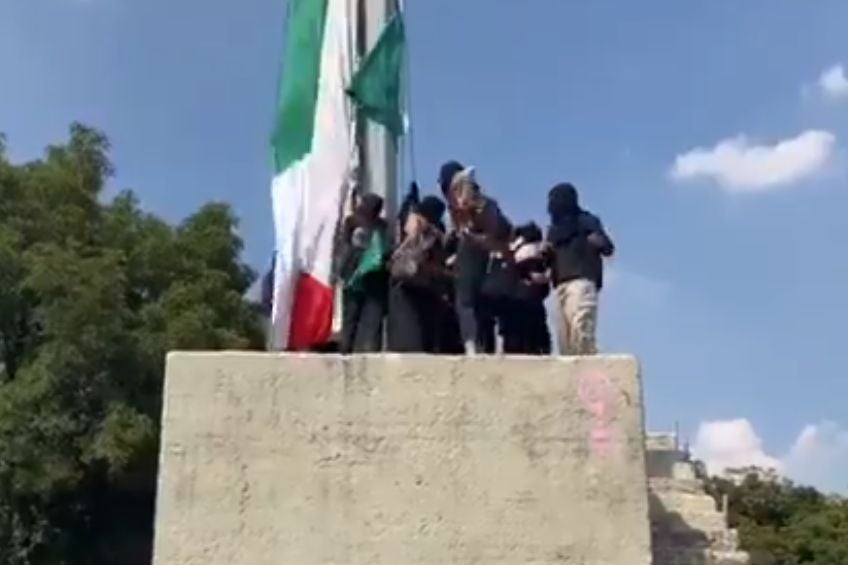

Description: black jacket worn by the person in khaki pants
[547,210,615,290]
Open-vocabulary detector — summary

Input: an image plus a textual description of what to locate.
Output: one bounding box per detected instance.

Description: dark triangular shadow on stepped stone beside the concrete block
[648,491,712,565]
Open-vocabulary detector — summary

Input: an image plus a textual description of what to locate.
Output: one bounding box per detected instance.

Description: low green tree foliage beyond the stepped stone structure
[707,474,848,565]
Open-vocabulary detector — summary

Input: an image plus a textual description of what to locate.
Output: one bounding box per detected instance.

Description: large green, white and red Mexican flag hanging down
[271,0,403,351]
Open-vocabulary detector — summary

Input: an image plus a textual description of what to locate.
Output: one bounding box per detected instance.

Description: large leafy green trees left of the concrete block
[0,124,262,565]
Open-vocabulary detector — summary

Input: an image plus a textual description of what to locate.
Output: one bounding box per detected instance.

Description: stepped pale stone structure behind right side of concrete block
[646,434,748,565]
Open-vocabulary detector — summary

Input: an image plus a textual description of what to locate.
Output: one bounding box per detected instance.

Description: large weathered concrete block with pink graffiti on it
[154,353,651,565]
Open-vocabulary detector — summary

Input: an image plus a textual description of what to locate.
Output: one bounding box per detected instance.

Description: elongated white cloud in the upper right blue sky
[670,130,836,193]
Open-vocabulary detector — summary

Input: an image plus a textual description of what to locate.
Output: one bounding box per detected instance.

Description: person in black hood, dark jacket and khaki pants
[546,183,615,355]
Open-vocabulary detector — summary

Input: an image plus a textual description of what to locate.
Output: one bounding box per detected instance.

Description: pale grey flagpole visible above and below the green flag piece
[360,0,398,229]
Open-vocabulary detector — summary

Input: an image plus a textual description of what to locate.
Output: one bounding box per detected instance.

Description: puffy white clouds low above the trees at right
[692,418,848,493]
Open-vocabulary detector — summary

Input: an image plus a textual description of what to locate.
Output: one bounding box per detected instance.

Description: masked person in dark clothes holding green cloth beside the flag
[338,194,389,354]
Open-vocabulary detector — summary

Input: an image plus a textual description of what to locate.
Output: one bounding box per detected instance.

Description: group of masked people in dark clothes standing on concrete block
[336,161,614,355]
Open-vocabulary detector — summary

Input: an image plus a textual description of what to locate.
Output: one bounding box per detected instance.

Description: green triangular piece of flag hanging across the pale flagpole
[348,12,406,137]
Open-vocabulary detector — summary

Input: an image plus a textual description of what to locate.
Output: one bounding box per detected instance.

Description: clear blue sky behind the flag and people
[0,0,848,489]
